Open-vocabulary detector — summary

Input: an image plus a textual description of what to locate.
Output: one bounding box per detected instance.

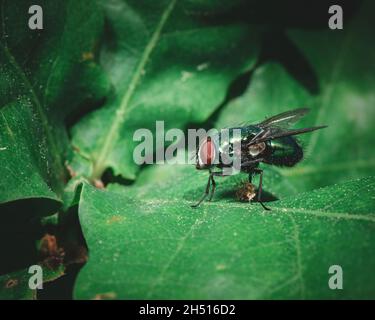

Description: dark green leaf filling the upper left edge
[0,0,108,202]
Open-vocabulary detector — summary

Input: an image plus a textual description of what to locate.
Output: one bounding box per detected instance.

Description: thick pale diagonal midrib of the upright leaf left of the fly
[91,0,177,180]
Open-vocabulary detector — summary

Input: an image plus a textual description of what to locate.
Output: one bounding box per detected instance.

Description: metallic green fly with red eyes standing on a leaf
[192,108,327,210]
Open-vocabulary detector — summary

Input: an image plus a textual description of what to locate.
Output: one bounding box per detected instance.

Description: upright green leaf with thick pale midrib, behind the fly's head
[72,0,258,179]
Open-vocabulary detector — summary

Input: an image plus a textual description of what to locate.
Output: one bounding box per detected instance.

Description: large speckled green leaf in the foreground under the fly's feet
[75,166,375,299]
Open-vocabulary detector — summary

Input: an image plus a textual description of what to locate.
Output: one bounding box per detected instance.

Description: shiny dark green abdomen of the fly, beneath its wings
[264,137,303,167]
